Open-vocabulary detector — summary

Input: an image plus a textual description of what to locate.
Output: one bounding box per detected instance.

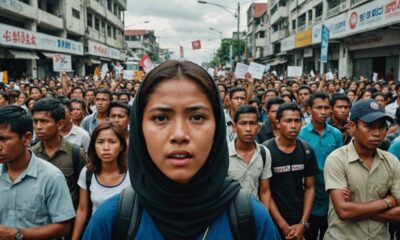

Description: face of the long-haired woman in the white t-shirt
[95,129,122,162]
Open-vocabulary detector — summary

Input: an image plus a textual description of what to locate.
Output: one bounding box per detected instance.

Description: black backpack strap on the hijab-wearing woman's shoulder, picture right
[228,189,256,240]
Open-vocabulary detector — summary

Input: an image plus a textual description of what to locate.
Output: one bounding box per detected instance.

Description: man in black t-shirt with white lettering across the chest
[263,103,317,239]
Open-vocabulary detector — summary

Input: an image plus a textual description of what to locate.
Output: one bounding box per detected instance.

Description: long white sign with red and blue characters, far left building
[0,23,83,55]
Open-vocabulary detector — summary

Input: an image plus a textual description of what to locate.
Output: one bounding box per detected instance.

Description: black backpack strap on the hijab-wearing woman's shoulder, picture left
[112,186,142,240]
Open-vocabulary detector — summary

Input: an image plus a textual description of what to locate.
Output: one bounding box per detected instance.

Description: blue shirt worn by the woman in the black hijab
[83,195,280,240]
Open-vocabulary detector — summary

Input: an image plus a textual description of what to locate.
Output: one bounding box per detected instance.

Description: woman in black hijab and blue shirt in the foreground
[84,61,279,239]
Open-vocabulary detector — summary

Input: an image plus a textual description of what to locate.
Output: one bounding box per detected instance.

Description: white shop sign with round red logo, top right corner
[347,0,400,34]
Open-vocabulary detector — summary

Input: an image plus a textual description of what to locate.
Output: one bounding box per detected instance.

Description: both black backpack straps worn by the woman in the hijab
[112,187,256,240]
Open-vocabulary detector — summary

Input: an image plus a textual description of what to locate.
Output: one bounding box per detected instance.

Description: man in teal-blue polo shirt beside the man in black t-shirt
[299,92,343,240]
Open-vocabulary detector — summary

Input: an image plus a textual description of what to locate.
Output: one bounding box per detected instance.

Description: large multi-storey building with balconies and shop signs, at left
[0,0,127,78]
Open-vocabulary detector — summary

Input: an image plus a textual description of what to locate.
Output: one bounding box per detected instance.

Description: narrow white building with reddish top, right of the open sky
[246,3,269,62]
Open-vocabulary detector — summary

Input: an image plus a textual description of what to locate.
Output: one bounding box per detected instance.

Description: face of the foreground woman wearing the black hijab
[142,78,216,183]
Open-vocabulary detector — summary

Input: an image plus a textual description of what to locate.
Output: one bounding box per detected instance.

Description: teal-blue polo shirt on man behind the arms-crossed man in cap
[299,121,343,216]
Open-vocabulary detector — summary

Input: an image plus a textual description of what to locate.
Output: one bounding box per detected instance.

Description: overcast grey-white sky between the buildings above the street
[125,0,266,64]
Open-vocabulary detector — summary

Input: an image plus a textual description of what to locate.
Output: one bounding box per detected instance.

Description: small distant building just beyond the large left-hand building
[125,29,159,58]
